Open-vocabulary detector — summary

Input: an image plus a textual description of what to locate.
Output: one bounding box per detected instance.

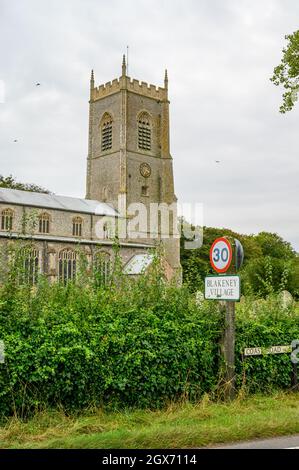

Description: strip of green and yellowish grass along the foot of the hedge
[0,393,299,449]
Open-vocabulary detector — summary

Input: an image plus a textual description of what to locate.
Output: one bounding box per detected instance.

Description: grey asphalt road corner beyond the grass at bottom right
[214,434,299,449]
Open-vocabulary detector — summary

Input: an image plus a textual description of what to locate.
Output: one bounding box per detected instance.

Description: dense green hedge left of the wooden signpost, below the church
[0,276,221,415]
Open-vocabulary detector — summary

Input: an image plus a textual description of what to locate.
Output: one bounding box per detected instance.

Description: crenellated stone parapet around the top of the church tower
[91,76,167,101]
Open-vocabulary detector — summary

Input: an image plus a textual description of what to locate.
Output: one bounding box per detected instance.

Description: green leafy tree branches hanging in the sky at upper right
[270,31,299,113]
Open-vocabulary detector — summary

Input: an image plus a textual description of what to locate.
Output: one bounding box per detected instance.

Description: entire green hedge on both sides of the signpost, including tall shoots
[0,242,299,416]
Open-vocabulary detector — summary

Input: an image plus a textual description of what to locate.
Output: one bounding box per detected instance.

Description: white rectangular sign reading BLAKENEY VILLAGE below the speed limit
[205,276,240,300]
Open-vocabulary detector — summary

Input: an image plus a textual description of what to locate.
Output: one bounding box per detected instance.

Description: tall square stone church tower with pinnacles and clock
[86,56,181,275]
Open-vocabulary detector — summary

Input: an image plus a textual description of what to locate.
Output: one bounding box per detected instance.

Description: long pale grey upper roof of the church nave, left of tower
[0,188,119,217]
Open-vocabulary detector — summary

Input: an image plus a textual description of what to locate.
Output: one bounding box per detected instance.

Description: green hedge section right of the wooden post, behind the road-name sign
[236,295,299,392]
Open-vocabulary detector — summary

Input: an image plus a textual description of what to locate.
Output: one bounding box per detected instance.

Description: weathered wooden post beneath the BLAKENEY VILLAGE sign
[223,301,235,400]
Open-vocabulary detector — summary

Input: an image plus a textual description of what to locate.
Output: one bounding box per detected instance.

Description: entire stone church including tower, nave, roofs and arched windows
[0,56,181,282]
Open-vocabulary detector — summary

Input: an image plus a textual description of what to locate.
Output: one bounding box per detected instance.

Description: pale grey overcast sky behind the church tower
[0,0,299,250]
